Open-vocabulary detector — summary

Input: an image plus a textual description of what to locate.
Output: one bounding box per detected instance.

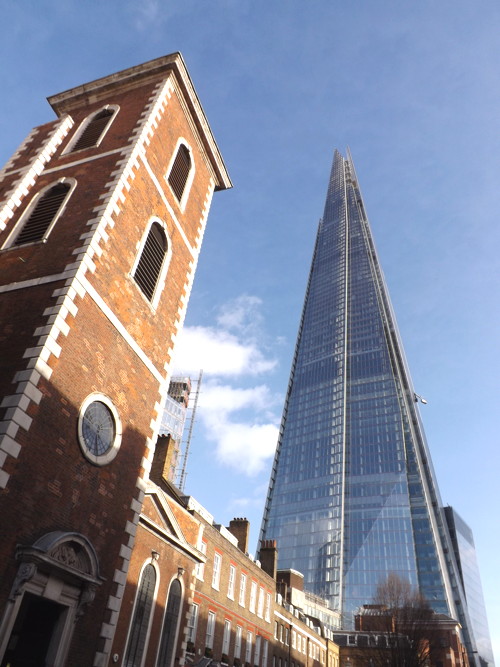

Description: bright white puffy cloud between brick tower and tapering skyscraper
[175,295,282,476]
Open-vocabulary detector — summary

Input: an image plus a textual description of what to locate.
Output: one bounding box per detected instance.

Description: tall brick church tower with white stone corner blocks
[0,54,231,667]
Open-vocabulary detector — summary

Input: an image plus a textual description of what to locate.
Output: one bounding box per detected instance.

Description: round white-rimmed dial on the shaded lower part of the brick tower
[78,394,121,465]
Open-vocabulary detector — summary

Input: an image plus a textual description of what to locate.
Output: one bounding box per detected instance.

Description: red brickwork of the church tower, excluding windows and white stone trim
[0,58,225,666]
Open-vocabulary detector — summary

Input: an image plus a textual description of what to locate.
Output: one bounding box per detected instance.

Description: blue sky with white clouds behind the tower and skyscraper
[0,0,500,664]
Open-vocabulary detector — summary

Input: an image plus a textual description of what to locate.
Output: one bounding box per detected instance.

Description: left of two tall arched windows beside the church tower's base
[123,563,156,667]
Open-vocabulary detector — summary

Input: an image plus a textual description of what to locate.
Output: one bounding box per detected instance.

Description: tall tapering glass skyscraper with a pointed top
[261,151,482,651]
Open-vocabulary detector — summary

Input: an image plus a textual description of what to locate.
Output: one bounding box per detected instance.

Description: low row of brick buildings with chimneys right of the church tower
[112,438,338,667]
